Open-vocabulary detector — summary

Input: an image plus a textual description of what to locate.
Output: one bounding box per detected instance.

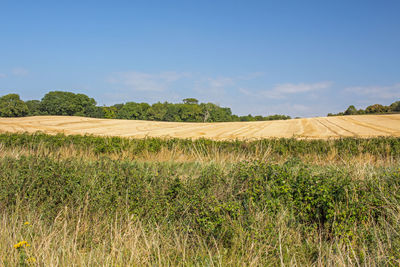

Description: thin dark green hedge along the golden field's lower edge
[0,133,400,159]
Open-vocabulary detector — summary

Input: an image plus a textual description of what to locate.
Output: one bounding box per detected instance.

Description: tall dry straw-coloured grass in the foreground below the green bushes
[0,207,400,266]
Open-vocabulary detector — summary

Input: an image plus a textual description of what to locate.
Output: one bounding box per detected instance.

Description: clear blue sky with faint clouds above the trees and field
[0,0,400,117]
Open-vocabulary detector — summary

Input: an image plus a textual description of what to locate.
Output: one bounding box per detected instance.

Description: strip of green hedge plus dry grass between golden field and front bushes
[0,133,400,164]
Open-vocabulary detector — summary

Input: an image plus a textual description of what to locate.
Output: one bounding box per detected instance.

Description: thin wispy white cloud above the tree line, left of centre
[107,71,190,92]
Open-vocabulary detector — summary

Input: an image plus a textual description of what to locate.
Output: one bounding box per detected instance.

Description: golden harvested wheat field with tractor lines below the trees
[0,114,400,140]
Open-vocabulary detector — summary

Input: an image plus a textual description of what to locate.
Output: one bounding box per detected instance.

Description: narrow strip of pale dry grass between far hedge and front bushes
[0,143,400,167]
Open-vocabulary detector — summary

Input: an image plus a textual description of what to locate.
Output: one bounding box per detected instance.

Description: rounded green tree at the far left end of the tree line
[0,94,29,117]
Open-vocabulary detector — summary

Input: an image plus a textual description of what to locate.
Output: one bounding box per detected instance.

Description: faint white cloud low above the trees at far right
[345,83,400,99]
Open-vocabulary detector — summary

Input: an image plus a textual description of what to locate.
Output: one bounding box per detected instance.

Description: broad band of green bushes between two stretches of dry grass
[0,157,400,250]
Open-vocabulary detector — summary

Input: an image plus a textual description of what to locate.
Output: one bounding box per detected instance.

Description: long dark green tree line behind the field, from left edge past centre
[0,91,290,122]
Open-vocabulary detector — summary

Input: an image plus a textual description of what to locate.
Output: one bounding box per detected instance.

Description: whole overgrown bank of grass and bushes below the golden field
[0,134,400,266]
